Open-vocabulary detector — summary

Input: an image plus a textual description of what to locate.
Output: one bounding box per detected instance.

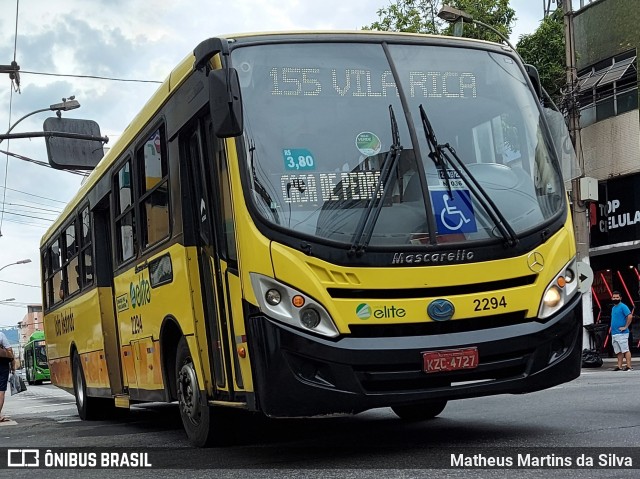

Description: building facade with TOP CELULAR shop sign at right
[574,0,640,353]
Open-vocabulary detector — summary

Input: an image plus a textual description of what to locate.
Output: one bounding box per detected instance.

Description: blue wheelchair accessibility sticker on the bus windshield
[431,190,478,234]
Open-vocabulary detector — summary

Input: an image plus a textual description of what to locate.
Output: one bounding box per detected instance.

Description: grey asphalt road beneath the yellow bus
[0,364,640,479]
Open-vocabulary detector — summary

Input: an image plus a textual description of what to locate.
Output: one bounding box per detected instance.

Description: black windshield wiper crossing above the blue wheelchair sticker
[420,105,518,246]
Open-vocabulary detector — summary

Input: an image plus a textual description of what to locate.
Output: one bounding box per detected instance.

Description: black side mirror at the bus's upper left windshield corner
[208,68,244,138]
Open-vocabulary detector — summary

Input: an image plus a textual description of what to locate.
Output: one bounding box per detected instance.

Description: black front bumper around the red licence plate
[247,295,582,417]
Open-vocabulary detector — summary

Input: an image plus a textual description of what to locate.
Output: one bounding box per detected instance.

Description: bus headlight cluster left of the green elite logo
[250,273,340,338]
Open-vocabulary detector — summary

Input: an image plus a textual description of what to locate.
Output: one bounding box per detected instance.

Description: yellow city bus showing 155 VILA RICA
[41,31,582,446]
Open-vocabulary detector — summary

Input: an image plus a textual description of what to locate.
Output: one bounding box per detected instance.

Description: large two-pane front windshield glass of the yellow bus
[232,43,564,247]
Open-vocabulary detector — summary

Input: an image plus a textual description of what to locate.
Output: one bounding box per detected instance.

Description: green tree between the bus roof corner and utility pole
[516,8,566,104]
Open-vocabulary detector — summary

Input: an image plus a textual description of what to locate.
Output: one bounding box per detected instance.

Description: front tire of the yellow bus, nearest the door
[175,336,215,447]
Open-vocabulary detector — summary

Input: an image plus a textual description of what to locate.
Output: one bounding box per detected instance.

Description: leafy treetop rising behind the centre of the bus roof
[364,0,516,42]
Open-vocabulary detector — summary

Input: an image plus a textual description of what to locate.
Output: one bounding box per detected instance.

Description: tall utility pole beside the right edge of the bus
[558,0,593,332]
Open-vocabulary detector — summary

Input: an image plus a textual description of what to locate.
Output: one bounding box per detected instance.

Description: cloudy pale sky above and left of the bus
[0,0,556,326]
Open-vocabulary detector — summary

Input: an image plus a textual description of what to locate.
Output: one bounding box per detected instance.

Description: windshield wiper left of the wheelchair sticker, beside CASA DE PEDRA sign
[349,105,402,255]
